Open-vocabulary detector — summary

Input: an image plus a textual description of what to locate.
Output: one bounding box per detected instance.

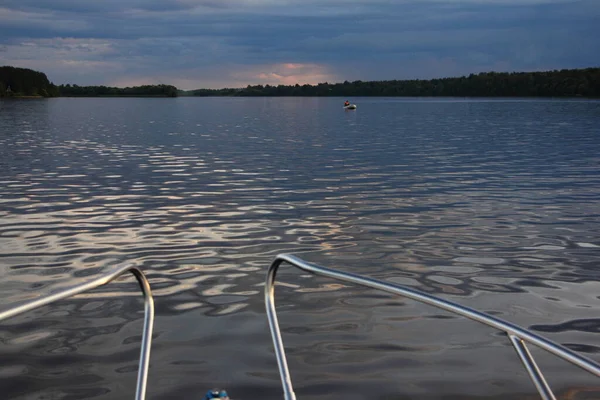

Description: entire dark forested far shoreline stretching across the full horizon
[0,66,600,98]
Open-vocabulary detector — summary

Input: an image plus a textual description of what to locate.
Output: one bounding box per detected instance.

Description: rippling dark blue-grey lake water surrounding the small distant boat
[0,98,600,400]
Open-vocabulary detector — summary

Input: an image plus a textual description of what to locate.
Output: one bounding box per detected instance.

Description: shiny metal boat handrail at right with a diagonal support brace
[265,254,600,400]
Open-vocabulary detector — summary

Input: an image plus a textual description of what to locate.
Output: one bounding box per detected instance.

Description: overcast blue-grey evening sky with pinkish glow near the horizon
[0,0,600,89]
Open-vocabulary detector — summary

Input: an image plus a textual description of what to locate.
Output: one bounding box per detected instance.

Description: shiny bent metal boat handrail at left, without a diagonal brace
[0,264,154,400]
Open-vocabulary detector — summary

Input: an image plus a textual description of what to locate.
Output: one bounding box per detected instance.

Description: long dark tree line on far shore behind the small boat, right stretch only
[188,68,600,97]
